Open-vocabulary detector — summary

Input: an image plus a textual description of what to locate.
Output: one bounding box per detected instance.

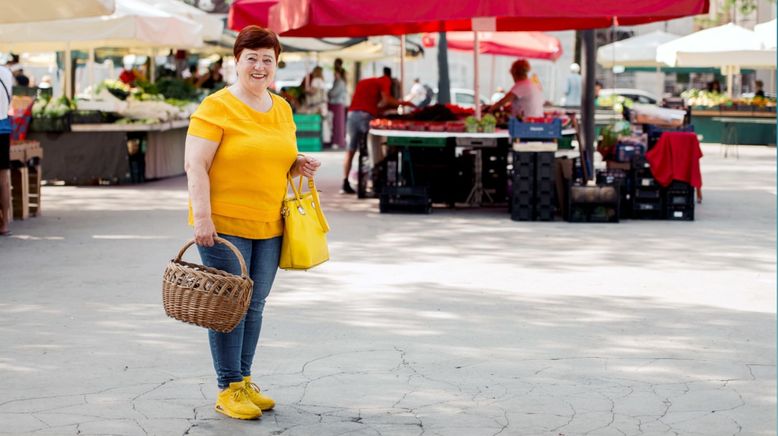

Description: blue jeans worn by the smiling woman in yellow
[197,234,282,389]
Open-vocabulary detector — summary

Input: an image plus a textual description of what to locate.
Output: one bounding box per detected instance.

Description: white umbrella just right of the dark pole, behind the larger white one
[597,30,680,68]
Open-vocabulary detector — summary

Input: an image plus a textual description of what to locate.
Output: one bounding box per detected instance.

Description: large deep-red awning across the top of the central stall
[269,0,708,37]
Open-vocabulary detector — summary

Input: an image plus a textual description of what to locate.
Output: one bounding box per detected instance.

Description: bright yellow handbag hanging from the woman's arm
[278,174,330,270]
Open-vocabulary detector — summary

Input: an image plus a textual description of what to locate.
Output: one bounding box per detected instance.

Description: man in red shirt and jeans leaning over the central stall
[341,67,408,194]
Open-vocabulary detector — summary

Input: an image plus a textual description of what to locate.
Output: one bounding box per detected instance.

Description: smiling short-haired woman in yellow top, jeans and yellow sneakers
[185,26,321,419]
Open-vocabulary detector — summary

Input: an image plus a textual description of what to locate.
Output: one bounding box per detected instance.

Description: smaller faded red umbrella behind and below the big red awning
[422,32,562,61]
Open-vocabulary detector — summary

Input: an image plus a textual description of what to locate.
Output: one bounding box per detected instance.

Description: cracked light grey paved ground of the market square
[0,146,776,436]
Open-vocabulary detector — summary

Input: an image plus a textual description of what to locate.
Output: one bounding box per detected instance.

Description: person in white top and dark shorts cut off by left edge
[0,62,14,236]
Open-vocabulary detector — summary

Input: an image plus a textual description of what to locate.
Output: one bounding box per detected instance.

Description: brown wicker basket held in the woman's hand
[162,237,254,333]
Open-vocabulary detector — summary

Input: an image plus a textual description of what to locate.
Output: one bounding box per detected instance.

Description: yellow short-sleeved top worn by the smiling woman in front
[188,88,297,239]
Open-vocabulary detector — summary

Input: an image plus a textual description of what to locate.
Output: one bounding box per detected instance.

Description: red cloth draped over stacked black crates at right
[646,132,702,188]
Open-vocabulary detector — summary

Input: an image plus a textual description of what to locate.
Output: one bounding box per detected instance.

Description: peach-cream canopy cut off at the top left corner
[0,0,115,24]
